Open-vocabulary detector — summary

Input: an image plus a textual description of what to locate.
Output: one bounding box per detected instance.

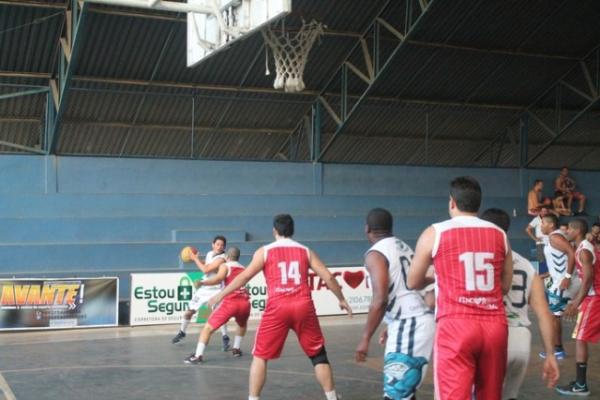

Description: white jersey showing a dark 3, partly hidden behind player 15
[504,251,536,326]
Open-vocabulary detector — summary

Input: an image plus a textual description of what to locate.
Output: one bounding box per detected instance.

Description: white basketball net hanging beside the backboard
[262,20,326,93]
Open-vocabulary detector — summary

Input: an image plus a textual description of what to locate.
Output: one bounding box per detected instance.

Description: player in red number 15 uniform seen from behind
[408,177,512,400]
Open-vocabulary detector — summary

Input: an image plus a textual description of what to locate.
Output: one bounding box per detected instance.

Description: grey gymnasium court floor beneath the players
[0,316,600,400]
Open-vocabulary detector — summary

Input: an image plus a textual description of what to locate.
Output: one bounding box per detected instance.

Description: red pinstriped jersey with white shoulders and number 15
[432,216,508,323]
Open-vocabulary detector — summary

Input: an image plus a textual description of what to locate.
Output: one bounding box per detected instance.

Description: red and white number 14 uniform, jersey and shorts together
[252,238,325,360]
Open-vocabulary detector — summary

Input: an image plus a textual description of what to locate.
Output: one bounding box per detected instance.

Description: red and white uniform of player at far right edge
[573,240,600,343]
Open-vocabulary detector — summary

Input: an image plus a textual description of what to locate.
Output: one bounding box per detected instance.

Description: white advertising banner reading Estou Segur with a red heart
[130,267,371,326]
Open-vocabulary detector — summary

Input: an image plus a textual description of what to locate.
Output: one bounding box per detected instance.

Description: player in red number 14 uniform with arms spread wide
[209,214,352,400]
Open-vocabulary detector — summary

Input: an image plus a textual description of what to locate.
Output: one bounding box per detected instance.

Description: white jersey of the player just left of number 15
[365,236,428,321]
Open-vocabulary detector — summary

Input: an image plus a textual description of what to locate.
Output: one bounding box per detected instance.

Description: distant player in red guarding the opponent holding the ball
[185,247,250,364]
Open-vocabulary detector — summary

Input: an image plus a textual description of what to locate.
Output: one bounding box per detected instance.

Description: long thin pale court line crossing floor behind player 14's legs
[0,364,381,386]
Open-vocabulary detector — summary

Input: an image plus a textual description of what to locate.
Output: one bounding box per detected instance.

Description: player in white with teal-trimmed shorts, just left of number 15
[356,208,435,399]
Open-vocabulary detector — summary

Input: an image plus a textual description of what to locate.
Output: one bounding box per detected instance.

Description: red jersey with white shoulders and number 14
[263,238,311,301]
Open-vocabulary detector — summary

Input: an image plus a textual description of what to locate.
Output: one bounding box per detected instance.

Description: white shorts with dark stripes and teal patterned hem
[383,313,435,400]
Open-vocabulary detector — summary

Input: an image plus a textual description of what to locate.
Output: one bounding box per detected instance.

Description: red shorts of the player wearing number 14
[252,298,325,360]
